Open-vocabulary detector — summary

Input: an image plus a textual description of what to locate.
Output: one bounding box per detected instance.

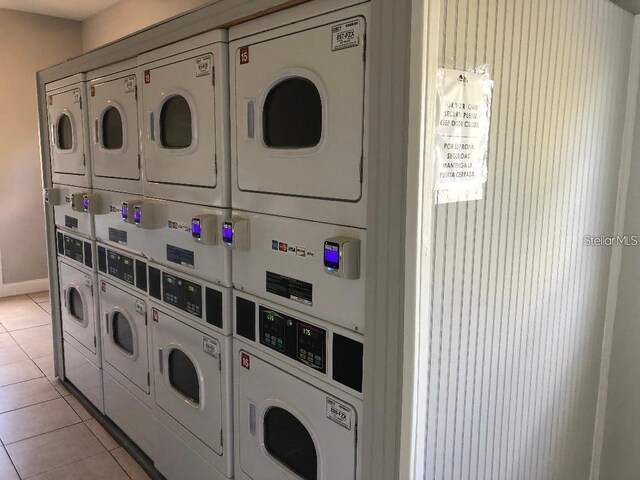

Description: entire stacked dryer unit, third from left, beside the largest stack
[138,31,233,479]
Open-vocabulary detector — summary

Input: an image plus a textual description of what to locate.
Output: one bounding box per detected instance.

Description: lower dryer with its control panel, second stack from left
[98,244,158,459]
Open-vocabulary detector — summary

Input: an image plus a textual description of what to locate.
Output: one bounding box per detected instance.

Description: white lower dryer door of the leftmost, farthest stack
[60,263,96,354]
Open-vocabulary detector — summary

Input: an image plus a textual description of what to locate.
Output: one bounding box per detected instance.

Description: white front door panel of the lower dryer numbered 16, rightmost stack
[234,350,358,480]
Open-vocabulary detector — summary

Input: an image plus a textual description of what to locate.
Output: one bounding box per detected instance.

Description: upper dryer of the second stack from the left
[87,59,142,194]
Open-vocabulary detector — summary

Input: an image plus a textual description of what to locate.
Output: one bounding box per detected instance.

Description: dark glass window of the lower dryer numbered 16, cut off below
[264,407,318,480]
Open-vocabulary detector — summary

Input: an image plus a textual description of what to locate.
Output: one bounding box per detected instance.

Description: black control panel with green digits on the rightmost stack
[259,306,327,373]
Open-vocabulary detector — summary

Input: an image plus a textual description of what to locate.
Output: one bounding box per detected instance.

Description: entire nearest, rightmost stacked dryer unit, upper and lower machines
[230,2,369,480]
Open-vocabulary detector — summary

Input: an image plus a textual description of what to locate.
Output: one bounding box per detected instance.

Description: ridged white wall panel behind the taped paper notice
[424,0,633,480]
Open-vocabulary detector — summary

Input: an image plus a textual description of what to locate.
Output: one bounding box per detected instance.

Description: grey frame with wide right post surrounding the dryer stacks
[36,0,430,480]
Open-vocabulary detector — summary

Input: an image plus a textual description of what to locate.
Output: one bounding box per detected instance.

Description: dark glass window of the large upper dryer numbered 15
[262,77,322,148]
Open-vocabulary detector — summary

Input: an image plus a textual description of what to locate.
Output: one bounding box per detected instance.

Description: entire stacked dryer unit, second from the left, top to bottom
[87,59,157,458]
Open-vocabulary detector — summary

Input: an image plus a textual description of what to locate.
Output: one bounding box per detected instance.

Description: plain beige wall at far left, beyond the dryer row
[0,9,82,296]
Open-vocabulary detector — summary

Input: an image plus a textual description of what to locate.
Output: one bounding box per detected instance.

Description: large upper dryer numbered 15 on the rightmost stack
[229,0,370,228]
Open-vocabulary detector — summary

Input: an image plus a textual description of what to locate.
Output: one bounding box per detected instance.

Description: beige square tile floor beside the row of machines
[0,292,149,480]
